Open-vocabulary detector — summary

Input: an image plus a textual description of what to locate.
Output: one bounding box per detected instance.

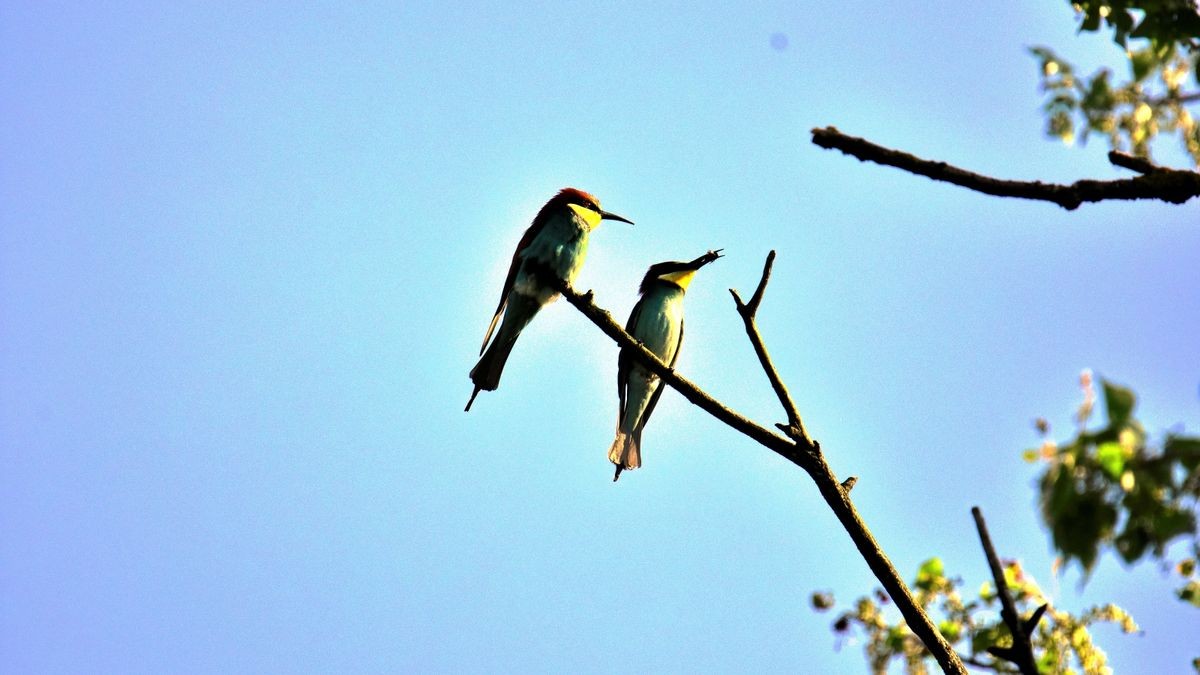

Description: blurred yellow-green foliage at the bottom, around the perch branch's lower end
[812,557,1138,675]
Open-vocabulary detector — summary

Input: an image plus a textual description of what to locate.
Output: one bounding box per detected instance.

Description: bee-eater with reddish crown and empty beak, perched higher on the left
[466,187,634,411]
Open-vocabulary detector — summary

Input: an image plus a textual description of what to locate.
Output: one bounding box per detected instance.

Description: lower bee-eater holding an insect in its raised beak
[608,249,722,480]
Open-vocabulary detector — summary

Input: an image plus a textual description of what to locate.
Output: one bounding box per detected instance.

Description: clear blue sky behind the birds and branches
[0,0,1200,673]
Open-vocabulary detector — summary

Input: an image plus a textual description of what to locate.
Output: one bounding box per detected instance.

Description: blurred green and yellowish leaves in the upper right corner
[1030,0,1200,166]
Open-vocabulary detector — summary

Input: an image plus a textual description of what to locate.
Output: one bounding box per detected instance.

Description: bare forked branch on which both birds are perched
[544,251,966,674]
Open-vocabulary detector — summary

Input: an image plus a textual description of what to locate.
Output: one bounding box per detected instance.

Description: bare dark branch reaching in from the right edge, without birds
[812,126,1200,211]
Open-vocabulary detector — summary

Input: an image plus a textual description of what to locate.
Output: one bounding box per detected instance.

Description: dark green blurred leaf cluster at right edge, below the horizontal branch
[1024,370,1200,588]
